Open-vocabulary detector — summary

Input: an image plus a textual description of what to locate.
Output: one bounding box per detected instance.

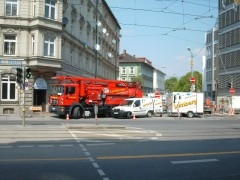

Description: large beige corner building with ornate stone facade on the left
[0,0,120,114]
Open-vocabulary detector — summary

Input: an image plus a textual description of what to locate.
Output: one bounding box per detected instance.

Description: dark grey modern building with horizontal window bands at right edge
[217,0,240,96]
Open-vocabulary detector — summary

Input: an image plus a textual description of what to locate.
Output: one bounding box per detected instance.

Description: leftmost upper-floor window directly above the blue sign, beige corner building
[4,35,16,55]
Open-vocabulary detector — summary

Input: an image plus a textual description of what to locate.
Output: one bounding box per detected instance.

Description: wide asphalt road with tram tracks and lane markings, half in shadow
[0,116,240,180]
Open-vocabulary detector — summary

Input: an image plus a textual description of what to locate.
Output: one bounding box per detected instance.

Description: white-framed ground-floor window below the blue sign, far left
[1,75,17,101]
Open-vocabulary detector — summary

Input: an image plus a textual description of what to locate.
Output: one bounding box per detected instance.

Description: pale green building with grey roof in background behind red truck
[119,50,165,93]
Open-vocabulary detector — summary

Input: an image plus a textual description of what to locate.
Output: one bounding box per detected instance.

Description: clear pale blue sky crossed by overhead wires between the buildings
[106,0,218,79]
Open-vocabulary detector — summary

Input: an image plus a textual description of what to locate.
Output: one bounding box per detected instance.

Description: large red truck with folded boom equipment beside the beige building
[49,76,143,119]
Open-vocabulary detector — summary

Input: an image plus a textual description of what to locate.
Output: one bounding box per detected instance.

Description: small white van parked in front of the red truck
[112,98,163,118]
